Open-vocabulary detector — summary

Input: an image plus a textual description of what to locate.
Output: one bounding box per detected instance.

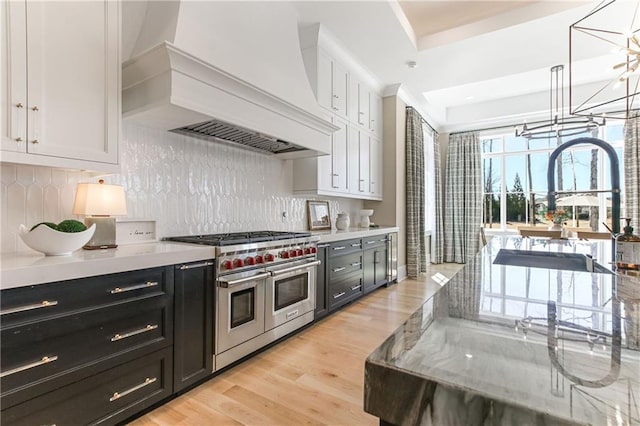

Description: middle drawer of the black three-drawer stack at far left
[0,297,173,407]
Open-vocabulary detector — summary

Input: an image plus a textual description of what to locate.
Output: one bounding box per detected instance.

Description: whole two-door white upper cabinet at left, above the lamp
[1,0,120,172]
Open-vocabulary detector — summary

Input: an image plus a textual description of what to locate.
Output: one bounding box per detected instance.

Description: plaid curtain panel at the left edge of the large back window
[444,132,482,263]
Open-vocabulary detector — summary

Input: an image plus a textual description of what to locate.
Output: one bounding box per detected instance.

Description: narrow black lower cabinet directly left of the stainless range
[173,261,215,392]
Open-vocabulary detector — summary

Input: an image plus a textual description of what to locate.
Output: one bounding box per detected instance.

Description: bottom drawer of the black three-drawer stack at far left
[2,348,173,426]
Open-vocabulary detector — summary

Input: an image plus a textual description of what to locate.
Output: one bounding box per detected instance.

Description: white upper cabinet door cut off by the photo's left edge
[0,1,27,152]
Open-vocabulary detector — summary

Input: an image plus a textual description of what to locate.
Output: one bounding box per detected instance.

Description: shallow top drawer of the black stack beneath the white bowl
[0,267,173,328]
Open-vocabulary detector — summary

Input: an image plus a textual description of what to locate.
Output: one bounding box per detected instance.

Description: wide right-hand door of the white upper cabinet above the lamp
[26,0,119,163]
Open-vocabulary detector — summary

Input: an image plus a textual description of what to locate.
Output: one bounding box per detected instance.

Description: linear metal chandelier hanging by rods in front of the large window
[516,65,606,139]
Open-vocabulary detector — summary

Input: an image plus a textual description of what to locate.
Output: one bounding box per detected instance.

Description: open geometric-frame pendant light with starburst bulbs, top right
[569,0,640,119]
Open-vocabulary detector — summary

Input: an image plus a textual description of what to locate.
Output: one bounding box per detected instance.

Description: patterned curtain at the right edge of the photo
[621,113,640,234]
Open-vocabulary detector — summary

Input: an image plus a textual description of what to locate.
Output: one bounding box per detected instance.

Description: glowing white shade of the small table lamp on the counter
[73,183,127,216]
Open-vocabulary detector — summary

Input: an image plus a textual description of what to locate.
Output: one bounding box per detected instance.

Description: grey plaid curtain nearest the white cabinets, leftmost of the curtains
[406,107,427,278]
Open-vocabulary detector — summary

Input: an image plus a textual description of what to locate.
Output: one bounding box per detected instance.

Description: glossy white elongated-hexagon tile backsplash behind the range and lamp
[0,124,362,253]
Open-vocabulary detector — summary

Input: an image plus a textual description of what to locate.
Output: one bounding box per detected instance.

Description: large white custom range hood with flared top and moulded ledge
[122,1,337,159]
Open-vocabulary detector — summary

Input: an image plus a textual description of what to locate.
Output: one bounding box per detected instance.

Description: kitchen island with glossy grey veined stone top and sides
[364,237,640,425]
